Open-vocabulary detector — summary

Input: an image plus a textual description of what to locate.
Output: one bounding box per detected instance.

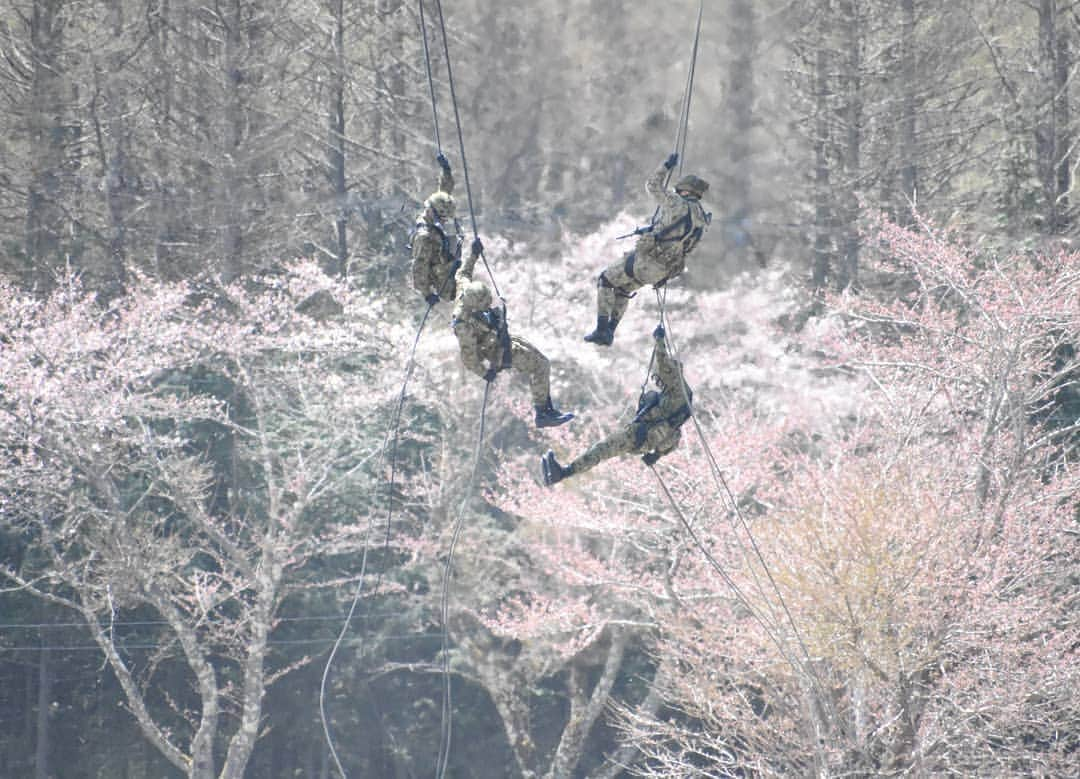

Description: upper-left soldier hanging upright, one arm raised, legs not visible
[411,151,461,306]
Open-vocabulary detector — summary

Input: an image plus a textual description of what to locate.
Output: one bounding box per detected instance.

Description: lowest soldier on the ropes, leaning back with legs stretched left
[541,325,693,486]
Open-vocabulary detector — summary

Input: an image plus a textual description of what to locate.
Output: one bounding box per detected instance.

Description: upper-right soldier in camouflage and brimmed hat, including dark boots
[585,155,711,346]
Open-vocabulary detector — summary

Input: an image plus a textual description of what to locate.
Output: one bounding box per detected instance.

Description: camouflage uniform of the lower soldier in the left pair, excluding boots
[454,243,551,406]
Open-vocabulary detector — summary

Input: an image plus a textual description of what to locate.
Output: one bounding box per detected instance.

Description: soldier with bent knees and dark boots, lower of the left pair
[453,238,573,428]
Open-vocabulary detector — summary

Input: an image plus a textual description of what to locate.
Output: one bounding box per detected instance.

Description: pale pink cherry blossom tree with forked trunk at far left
[0,265,391,779]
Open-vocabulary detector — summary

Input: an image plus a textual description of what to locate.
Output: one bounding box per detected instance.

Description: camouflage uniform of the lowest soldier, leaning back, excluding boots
[567,338,689,474]
